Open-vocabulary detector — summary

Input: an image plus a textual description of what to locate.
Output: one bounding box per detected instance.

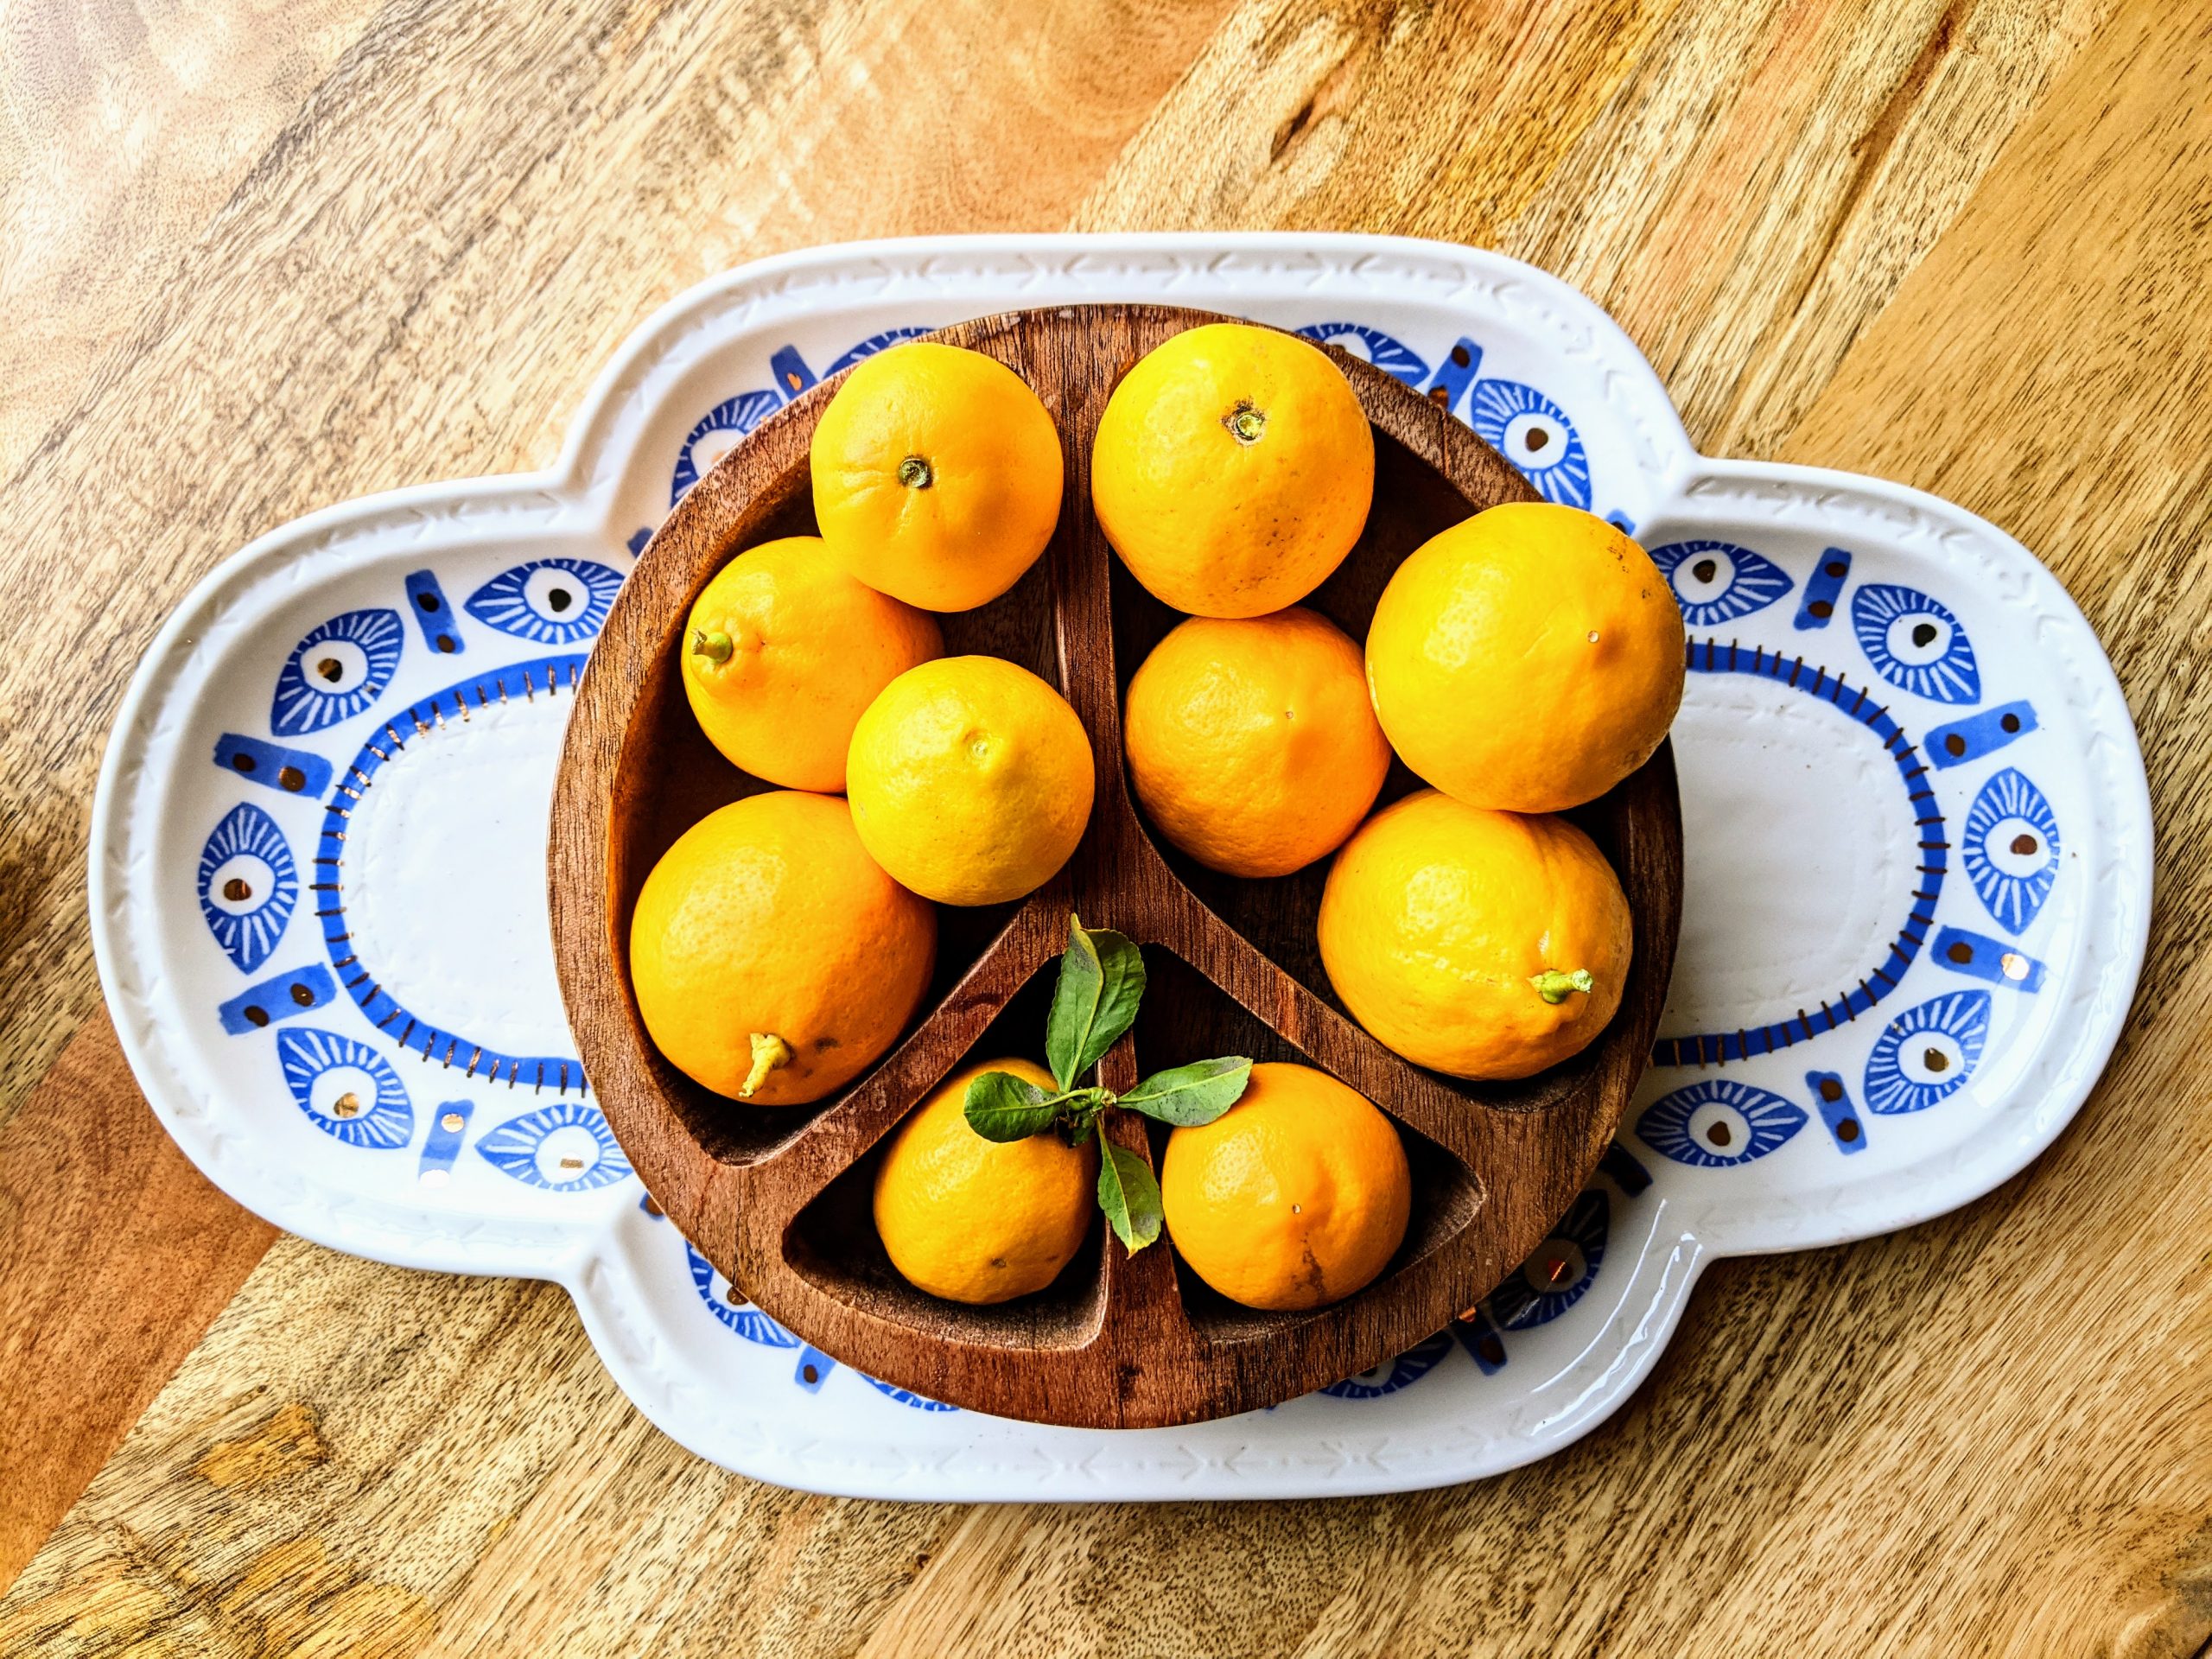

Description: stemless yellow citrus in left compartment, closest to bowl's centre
[845,657,1093,905]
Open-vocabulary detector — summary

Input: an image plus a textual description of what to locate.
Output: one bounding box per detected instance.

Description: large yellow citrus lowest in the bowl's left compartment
[631,790,938,1106]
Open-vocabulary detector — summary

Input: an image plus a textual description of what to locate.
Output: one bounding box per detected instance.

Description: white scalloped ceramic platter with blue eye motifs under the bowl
[91,237,2150,1500]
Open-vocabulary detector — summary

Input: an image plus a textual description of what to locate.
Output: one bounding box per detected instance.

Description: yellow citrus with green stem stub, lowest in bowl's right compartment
[1320,790,1630,1092]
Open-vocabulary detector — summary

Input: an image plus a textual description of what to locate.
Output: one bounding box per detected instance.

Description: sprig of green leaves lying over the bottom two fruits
[963,916,1252,1252]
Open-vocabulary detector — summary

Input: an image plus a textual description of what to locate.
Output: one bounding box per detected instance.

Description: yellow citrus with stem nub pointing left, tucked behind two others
[679,536,944,794]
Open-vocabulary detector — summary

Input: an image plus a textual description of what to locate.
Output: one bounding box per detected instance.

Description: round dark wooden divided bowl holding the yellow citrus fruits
[550,305,1681,1427]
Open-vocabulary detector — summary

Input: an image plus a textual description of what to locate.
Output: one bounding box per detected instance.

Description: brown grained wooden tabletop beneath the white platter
[0,0,2212,1659]
